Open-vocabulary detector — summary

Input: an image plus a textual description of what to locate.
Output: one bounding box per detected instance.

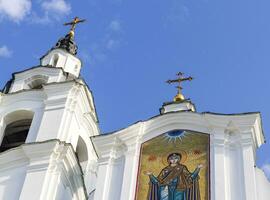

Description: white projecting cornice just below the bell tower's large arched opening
[0,139,87,198]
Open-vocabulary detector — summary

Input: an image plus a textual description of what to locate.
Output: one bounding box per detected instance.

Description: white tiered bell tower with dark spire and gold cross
[0,17,100,200]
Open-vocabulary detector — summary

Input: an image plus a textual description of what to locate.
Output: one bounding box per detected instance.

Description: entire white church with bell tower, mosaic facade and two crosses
[0,17,270,200]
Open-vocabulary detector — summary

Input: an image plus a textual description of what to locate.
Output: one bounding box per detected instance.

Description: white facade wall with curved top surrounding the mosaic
[92,112,270,200]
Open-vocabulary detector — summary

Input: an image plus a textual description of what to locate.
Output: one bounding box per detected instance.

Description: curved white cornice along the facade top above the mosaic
[91,112,264,155]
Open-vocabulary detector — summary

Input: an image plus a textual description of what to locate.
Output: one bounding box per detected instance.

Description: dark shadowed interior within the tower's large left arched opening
[0,119,32,152]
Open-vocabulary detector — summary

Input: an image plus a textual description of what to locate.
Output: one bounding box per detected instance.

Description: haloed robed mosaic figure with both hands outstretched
[145,153,203,200]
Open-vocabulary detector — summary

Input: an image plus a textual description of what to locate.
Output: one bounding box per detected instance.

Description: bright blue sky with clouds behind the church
[0,0,270,177]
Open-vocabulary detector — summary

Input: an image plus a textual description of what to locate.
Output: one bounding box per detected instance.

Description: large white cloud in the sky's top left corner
[0,0,32,23]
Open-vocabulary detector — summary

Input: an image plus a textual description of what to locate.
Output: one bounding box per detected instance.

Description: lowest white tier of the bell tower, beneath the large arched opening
[0,140,86,200]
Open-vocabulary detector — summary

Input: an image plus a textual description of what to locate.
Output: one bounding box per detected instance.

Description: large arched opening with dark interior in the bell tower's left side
[0,110,34,152]
